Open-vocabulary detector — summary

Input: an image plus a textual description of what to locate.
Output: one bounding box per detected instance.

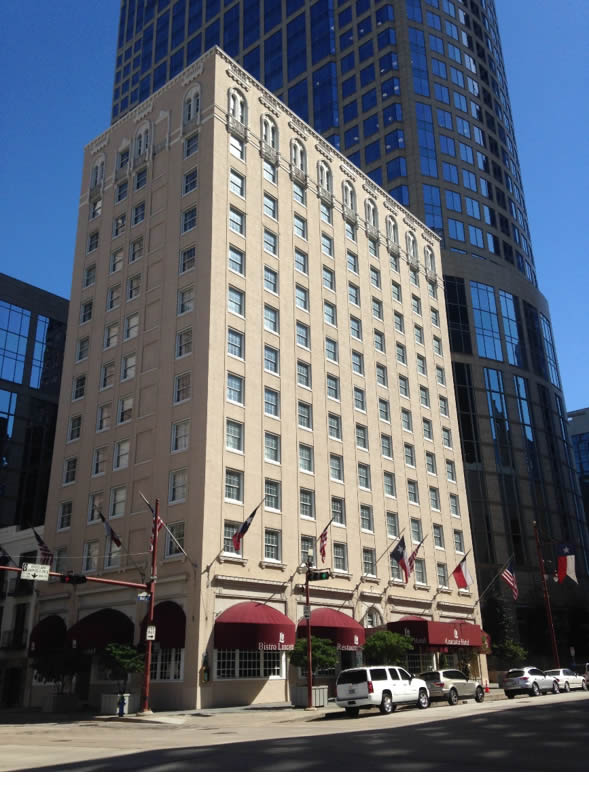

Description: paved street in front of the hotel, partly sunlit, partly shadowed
[0,693,589,772]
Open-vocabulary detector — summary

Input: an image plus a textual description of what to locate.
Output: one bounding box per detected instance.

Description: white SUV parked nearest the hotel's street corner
[335,665,429,717]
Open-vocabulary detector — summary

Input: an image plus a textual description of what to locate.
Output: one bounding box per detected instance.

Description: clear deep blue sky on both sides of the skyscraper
[0,0,589,410]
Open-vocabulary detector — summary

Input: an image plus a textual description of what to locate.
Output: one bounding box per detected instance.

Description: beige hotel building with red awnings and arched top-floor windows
[40,49,484,709]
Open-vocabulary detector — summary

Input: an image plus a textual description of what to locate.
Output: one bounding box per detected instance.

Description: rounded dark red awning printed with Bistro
[214,602,295,651]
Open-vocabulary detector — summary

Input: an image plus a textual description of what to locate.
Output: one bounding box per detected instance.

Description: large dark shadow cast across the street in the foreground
[23,701,589,772]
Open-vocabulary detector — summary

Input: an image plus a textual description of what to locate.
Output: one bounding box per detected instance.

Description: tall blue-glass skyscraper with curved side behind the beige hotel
[112,0,589,655]
